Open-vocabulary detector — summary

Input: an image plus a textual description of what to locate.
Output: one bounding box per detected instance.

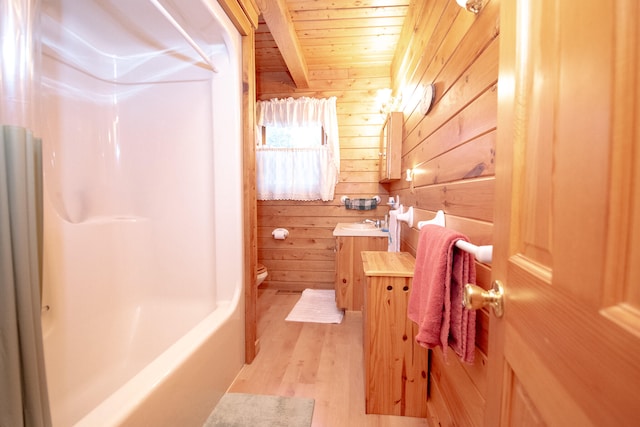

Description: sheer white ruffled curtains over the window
[256,97,340,201]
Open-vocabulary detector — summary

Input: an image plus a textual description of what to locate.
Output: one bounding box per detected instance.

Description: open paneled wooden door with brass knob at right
[485,0,640,426]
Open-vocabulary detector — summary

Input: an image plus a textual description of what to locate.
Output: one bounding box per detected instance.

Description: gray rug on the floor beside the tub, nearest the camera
[203,393,315,427]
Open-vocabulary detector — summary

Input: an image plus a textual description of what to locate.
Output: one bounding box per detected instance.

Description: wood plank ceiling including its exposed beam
[256,0,410,88]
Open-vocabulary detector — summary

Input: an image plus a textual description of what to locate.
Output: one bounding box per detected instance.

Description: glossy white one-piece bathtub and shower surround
[39,0,244,427]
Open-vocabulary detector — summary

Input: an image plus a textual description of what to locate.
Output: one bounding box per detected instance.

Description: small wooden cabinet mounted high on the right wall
[378,111,403,182]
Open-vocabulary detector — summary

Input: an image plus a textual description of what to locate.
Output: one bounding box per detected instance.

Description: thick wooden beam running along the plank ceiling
[257,0,309,89]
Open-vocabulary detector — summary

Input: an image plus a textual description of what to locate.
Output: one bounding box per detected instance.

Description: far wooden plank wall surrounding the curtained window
[256,23,391,290]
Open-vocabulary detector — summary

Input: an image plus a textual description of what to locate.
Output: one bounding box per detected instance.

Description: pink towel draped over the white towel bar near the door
[407,225,476,363]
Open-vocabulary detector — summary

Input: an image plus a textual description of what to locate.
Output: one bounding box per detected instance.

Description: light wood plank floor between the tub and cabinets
[229,289,427,427]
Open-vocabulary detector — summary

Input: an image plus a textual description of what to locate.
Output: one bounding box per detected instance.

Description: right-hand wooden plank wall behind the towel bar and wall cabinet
[390,0,499,426]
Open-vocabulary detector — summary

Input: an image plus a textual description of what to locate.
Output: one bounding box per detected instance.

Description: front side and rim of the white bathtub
[75,293,244,427]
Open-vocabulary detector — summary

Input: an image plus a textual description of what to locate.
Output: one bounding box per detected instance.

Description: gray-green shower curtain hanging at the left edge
[0,126,51,427]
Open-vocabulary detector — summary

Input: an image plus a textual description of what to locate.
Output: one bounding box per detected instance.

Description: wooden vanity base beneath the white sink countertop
[335,236,389,311]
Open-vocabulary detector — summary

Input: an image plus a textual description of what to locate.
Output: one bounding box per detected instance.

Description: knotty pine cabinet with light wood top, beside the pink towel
[362,252,429,418]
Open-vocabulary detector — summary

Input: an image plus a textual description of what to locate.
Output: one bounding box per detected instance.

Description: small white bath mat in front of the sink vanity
[285,289,344,323]
